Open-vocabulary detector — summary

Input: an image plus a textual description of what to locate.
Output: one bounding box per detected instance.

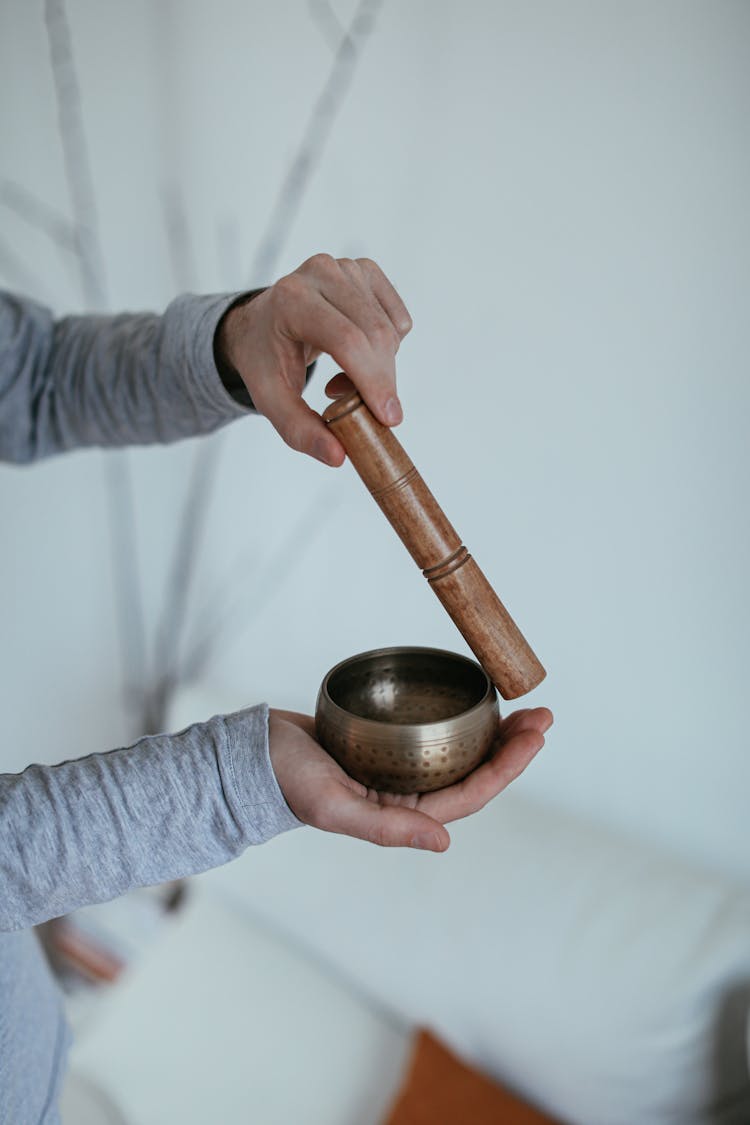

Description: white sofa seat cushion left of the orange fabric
[63,884,408,1125]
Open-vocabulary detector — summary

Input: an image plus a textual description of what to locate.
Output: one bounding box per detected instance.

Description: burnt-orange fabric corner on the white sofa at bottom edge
[383,1031,559,1125]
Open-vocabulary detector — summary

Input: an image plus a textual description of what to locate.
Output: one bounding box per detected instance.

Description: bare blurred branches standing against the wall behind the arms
[35,0,382,730]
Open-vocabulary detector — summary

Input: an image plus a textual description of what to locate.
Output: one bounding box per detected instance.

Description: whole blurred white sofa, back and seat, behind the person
[63,774,750,1125]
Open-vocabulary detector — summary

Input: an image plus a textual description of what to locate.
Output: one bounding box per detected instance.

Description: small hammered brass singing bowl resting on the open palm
[315,648,499,793]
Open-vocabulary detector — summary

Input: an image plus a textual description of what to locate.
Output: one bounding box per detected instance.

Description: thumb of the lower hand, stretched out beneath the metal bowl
[318,789,451,852]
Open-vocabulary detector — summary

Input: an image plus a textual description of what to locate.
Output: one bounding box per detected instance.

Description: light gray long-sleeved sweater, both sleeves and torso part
[0,293,299,1125]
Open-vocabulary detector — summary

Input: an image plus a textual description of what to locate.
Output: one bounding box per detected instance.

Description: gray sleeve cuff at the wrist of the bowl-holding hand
[219,703,302,844]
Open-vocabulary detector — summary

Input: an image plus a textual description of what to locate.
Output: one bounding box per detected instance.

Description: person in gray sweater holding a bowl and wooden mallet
[0,254,552,1125]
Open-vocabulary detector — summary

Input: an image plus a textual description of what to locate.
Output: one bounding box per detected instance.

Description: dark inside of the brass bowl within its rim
[327,649,489,723]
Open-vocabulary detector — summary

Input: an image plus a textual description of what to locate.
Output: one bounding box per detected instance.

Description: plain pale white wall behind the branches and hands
[0,0,750,879]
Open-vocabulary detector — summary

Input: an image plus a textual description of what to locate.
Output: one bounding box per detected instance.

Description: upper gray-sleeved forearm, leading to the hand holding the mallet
[0,294,247,462]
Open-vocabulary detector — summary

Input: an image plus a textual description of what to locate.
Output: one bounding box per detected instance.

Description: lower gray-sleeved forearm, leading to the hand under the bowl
[0,705,298,930]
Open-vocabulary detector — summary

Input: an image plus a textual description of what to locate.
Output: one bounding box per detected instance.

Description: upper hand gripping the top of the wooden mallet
[217,254,412,466]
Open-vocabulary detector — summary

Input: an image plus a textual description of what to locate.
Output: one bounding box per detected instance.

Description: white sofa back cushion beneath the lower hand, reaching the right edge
[201,793,750,1125]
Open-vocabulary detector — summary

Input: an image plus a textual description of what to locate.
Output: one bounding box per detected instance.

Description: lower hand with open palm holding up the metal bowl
[270,708,552,852]
